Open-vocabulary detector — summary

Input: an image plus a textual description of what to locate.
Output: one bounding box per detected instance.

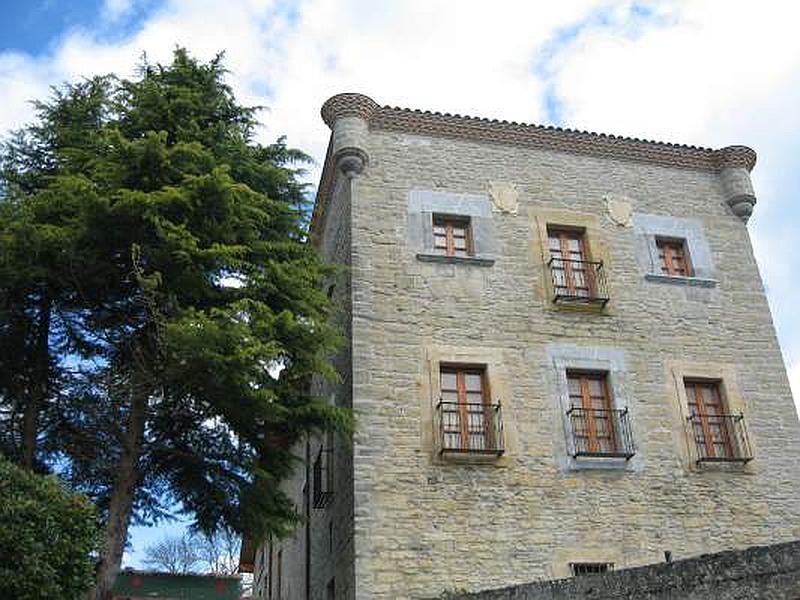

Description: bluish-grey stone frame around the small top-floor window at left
[407,190,497,267]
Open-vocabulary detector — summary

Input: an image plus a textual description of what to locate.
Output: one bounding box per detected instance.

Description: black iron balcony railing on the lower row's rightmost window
[687,414,753,464]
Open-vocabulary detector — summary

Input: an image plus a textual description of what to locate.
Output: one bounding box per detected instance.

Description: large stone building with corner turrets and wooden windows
[254,94,800,600]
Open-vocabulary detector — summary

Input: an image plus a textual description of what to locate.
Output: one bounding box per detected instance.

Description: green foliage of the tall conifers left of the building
[0,49,350,536]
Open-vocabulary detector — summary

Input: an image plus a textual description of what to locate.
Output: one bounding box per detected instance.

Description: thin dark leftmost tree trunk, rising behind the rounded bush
[22,295,52,470]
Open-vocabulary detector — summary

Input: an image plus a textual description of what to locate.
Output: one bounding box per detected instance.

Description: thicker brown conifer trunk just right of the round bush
[94,386,149,600]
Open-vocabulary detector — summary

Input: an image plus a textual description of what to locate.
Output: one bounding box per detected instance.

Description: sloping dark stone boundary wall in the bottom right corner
[440,541,800,600]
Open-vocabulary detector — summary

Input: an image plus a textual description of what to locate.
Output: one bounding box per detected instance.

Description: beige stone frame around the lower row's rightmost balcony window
[666,361,758,473]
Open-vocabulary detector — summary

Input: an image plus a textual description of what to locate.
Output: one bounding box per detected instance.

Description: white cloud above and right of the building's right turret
[536,0,800,414]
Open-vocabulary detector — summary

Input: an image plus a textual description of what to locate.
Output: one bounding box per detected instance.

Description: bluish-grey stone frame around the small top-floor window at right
[633,213,719,288]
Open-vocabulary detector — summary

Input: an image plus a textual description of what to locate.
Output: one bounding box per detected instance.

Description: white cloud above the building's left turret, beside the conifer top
[256,0,612,179]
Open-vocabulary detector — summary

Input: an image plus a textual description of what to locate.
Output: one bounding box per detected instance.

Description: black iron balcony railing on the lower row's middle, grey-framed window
[567,406,636,460]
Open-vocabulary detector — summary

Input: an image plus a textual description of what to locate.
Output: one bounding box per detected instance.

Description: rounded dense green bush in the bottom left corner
[0,459,97,600]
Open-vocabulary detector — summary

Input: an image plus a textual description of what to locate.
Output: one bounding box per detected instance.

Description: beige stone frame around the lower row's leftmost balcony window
[419,344,518,466]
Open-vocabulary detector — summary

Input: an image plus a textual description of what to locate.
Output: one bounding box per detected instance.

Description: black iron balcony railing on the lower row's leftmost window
[436,401,504,456]
